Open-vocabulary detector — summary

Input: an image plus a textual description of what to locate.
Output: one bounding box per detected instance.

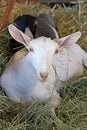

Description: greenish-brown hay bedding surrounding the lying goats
[0,3,87,130]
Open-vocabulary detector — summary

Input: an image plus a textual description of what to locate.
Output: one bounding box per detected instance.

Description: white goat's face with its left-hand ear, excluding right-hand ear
[9,25,59,81]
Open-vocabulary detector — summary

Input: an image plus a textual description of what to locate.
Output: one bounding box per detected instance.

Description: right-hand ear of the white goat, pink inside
[56,31,81,47]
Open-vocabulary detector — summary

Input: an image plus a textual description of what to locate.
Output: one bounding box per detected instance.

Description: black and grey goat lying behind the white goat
[13,13,59,39]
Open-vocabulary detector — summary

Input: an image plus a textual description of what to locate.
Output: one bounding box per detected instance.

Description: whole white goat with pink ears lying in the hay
[0,25,87,120]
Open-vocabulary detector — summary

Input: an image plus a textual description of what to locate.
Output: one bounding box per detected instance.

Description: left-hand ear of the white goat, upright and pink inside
[8,24,31,48]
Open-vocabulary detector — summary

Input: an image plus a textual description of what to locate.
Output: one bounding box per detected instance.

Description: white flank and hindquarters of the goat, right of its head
[53,34,87,81]
